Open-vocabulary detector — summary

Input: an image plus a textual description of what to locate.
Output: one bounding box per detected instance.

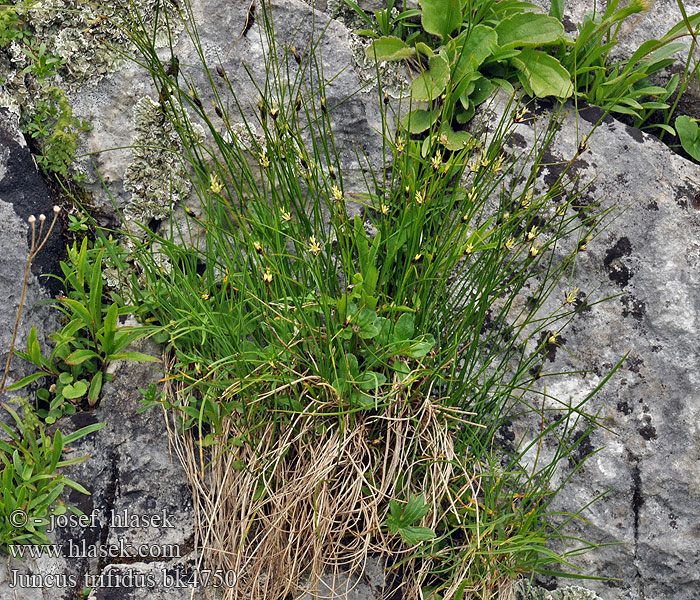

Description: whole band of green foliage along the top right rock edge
[357,0,700,142]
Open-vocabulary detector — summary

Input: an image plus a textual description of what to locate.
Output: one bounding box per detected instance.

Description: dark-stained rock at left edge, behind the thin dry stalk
[0,109,65,406]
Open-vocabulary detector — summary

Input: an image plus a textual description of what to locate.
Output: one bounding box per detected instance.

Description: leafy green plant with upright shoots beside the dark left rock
[8,238,158,423]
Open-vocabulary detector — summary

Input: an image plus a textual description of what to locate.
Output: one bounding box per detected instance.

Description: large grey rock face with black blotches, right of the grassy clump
[478,91,700,600]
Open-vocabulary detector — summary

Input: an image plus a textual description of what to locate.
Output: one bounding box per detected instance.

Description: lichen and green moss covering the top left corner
[0,0,179,177]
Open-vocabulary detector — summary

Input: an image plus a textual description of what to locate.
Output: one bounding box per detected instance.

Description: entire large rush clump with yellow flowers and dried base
[105,3,624,600]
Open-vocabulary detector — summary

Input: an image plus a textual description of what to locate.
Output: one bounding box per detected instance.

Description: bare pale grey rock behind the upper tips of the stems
[70,0,381,220]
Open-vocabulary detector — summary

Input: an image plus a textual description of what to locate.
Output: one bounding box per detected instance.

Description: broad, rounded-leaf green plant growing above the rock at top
[367,0,573,133]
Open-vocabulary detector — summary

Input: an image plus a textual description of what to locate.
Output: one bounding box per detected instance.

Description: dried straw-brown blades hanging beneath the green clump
[162,364,476,600]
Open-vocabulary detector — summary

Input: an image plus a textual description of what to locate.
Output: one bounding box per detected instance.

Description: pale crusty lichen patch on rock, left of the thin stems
[124,97,204,223]
